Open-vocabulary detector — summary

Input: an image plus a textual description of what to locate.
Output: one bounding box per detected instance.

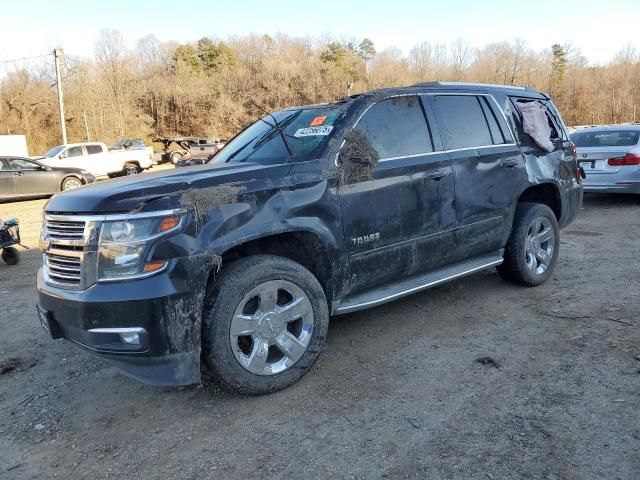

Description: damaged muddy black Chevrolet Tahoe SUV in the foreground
[37,83,582,393]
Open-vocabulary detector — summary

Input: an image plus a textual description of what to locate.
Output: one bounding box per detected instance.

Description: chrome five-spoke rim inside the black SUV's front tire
[229,280,314,375]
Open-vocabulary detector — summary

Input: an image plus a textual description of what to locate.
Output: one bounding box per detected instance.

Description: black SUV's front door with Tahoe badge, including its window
[338,95,455,294]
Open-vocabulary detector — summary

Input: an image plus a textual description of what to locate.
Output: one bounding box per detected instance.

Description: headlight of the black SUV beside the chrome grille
[98,215,181,281]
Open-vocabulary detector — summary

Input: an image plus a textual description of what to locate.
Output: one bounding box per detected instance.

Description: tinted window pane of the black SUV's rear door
[433,95,493,150]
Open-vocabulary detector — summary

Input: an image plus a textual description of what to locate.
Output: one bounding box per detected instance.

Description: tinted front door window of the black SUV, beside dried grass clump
[356,96,433,158]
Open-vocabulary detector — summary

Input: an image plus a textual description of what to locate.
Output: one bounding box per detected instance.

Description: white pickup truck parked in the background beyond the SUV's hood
[37,142,153,177]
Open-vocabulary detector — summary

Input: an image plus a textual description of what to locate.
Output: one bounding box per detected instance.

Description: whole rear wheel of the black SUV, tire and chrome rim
[497,203,560,287]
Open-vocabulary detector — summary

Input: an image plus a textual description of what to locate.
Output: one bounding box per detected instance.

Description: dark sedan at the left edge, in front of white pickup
[0,157,96,202]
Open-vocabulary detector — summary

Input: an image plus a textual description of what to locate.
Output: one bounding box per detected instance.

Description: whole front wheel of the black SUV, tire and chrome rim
[202,255,329,395]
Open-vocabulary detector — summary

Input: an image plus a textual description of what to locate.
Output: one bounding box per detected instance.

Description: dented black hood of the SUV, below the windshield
[45,163,291,213]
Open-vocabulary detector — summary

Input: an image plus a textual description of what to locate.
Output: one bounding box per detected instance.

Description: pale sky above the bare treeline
[0,0,640,66]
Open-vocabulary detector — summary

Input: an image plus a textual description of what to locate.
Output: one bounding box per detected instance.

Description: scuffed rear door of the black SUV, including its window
[426,93,527,259]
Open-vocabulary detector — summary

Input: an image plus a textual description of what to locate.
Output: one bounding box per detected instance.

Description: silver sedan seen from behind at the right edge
[571,124,640,194]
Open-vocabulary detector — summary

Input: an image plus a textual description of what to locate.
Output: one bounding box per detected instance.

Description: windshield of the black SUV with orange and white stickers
[212,105,346,165]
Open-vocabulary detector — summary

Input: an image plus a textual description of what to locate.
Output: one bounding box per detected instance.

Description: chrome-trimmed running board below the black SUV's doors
[332,249,504,315]
